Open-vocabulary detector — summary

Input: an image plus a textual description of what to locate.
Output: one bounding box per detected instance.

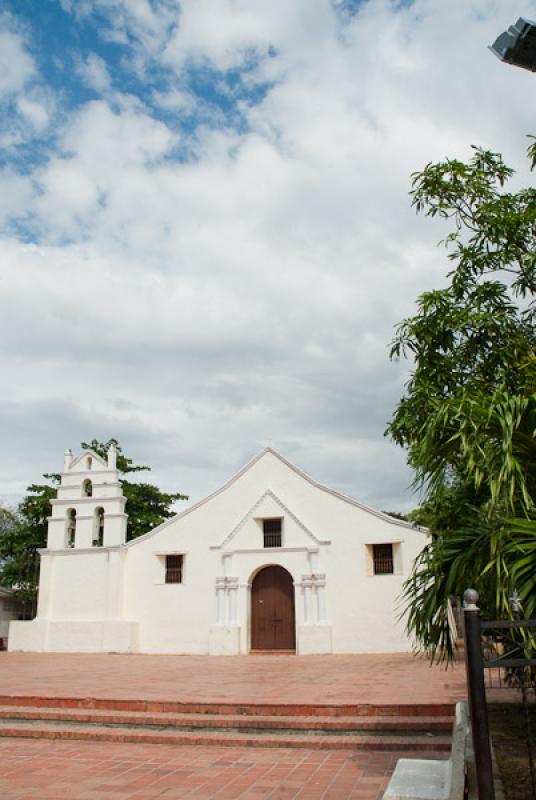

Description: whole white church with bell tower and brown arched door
[9,448,427,655]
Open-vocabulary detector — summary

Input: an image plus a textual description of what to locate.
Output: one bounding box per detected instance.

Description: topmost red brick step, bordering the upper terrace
[0,695,454,718]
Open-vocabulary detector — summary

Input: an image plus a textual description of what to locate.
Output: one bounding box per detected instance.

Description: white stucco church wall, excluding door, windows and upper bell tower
[10,450,426,653]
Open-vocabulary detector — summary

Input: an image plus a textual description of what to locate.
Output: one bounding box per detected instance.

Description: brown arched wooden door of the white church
[251,566,296,650]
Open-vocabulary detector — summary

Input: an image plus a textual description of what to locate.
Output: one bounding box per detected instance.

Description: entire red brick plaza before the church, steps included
[0,653,465,800]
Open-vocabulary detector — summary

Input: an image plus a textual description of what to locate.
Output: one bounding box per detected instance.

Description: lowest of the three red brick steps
[0,720,451,753]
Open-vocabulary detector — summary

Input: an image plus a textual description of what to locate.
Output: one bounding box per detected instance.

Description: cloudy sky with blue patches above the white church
[0,0,536,510]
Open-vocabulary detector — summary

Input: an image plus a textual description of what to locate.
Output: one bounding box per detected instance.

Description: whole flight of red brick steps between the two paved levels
[0,696,454,758]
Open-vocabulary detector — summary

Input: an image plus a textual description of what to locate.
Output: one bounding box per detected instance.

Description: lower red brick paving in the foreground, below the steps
[0,739,436,800]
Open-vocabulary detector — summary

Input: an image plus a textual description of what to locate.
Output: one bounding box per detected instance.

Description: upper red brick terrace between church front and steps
[0,653,465,705]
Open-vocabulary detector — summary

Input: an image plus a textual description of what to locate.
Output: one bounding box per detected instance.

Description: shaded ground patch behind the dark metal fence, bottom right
[488,703,536,800]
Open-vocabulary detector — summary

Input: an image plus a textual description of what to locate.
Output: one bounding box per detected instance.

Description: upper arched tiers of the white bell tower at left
[47,444,127,550]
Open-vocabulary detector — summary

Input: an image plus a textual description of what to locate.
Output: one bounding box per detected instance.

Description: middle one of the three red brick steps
[0,706,452,735]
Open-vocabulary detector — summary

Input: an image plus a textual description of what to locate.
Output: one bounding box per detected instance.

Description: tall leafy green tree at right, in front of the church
[387,139,536,658]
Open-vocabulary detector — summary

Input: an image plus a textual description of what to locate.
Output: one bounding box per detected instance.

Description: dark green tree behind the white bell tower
[0,439,188,615]
